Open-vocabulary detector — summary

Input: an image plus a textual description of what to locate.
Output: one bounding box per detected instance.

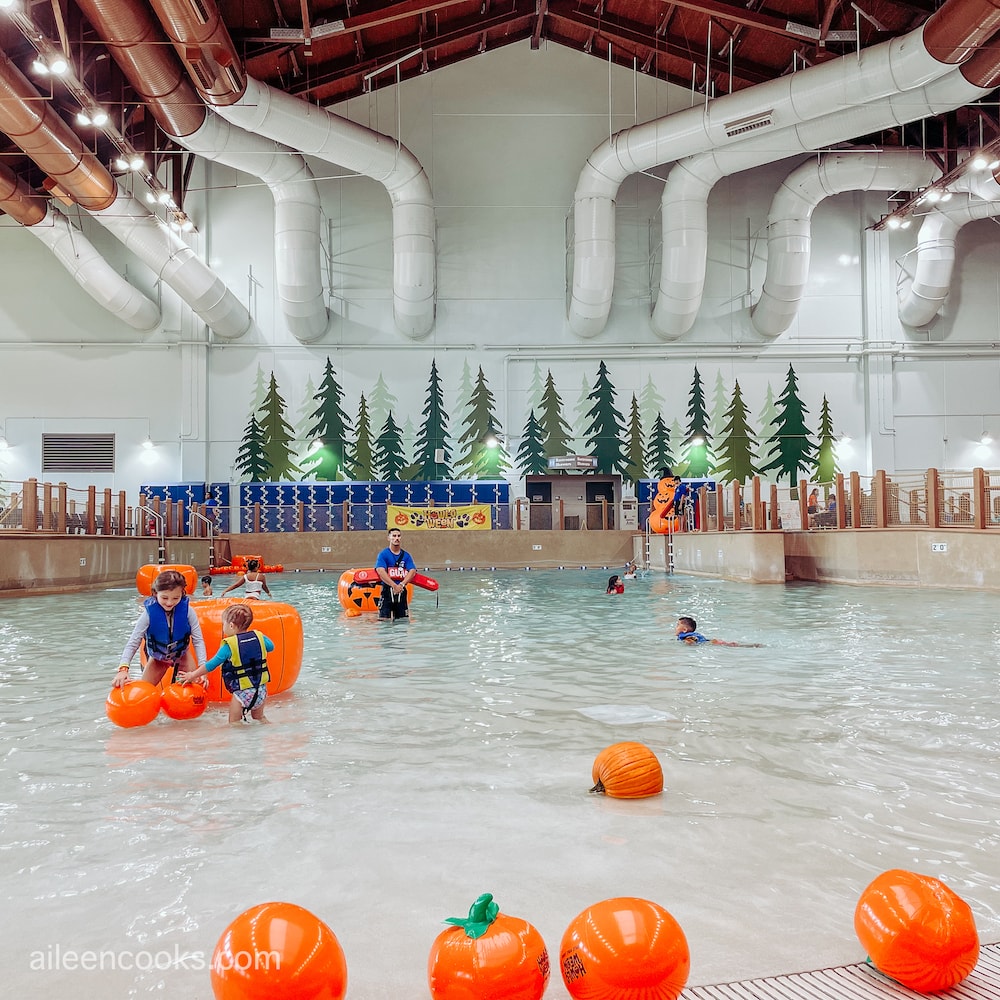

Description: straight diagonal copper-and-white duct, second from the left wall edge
[0,53,251,340]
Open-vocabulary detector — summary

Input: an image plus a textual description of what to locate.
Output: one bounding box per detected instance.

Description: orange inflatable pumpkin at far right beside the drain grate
[854,868,979,993]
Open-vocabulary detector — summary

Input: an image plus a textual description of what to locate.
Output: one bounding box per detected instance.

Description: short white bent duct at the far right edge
[898,172,1000,327]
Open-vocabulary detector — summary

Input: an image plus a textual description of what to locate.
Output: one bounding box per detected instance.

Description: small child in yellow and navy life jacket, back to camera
[177,604,274,722]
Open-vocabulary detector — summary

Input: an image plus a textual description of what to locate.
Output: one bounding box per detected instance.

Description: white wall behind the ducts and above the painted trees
[0,42,1000,490]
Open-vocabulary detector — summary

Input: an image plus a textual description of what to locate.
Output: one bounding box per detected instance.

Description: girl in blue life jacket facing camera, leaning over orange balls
[114,569,205,687]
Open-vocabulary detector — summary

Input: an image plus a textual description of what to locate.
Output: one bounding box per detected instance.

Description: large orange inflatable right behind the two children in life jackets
[140,597,302,704]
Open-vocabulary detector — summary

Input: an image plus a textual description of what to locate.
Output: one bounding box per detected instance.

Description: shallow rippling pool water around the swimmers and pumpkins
[0,571,1000,1000]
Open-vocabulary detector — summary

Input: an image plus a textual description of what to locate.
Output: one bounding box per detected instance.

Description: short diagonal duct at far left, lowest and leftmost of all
[0,164,160,332]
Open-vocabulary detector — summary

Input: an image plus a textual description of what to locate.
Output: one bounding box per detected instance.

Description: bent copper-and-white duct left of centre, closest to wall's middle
[151,0,438,338]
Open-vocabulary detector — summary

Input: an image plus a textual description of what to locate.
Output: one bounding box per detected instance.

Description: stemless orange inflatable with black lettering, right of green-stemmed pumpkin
[559,896,691,1000]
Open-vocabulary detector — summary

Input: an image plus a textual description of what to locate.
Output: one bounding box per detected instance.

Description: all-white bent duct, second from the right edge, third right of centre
[750,149,941,337]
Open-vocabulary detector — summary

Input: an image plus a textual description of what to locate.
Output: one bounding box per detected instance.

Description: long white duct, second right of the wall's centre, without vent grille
[651,41,1000,340]
